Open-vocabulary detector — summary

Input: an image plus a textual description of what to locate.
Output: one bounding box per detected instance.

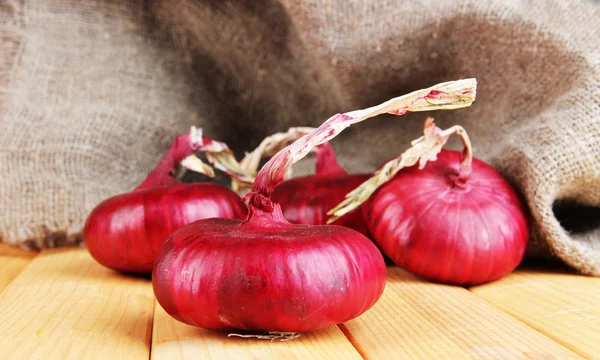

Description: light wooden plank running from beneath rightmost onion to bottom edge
[340,267,581,359]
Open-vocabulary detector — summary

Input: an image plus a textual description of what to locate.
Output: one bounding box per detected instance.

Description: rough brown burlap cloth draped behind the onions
[0,0,600,275]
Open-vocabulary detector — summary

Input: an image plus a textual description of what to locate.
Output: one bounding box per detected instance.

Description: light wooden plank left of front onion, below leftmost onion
[0,248,154,360]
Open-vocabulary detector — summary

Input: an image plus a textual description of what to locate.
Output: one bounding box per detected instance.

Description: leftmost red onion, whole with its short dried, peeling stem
[83,128,247,273]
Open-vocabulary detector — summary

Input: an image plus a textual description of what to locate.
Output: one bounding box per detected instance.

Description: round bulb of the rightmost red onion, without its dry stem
[363,150,529,285]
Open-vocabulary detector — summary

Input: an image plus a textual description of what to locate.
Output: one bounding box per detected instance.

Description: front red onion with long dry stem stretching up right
[152,80,475,332]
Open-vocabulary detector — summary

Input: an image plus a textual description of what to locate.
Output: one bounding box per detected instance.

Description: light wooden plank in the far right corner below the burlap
[471,268,600,359]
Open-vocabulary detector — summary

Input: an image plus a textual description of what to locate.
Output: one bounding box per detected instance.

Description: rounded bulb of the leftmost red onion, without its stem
[83,183,247,274]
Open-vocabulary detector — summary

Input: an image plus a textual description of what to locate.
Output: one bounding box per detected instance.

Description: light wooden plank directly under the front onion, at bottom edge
[152,303,362,360]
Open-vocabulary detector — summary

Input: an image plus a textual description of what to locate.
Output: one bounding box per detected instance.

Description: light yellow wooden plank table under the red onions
[0,244,600,360]
